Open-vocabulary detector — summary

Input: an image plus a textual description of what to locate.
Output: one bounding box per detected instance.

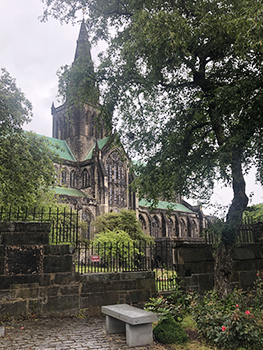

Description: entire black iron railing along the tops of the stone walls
[3,207,262,291]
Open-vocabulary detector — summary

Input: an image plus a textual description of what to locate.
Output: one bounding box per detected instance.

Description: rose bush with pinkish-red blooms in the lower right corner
[192,278,263,350]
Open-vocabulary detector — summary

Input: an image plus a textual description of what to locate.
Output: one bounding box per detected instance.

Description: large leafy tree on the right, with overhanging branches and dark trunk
[42,0,263,296]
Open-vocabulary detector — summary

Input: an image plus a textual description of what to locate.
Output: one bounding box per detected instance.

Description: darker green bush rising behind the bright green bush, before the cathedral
[92,209,153,243]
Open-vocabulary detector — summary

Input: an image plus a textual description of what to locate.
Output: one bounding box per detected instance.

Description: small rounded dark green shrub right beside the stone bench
[153,315,187,344]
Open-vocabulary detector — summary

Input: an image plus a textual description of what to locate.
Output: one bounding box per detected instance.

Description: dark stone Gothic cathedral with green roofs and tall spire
[46,22,207,240]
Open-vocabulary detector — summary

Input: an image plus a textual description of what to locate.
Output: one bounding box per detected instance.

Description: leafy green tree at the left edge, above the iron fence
[0,69,58,206]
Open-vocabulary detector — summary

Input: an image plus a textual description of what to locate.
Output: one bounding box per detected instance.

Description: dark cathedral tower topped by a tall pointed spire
[51,21,105,161]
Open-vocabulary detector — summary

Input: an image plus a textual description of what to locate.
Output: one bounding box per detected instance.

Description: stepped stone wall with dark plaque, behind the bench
[0,223,156,321]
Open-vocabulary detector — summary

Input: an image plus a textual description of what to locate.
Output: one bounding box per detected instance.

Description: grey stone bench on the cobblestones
[101,304,158,347]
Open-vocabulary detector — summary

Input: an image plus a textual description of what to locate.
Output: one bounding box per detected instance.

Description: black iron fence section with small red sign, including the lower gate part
[75,242,176,291]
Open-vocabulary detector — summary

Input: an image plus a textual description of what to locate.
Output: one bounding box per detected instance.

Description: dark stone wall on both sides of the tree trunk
[174,243,263,294]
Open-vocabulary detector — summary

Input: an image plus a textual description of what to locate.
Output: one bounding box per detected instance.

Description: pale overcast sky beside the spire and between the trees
[0,0,263,212]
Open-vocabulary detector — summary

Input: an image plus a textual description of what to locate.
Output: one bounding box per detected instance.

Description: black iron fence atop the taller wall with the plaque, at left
[0,207,79,244]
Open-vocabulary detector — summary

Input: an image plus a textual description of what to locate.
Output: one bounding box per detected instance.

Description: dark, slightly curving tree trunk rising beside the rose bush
[214,151,248,298]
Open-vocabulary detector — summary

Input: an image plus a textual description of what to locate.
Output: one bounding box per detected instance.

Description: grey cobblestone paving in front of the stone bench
[0,317,165,350]
